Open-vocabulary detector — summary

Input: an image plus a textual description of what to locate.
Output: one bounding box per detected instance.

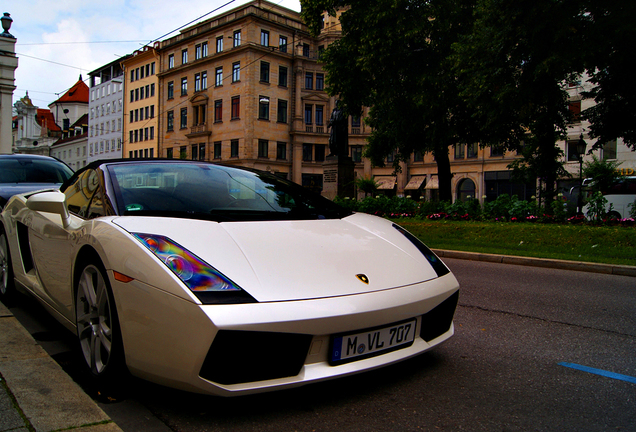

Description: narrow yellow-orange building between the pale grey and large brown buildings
[121,46,160,158]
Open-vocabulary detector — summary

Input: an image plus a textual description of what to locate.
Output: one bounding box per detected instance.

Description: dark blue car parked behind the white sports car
[0,154,73,209]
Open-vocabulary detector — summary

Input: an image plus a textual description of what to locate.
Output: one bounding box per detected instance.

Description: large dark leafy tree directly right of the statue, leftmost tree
[301,0,476,201]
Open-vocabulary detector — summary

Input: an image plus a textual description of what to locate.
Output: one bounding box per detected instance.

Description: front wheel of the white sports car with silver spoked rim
[75,261,126,384]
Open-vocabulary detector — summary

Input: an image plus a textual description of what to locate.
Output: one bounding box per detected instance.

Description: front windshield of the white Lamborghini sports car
[108,162,350,222]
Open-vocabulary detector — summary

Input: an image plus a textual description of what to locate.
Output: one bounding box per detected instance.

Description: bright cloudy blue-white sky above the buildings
[7,0,300,108]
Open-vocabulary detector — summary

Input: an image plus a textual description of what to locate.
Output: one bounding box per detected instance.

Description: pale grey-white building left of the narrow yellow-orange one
[87,59,124,162]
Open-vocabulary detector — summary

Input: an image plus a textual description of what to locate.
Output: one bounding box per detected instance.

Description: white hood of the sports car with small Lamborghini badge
[113,214,437,301]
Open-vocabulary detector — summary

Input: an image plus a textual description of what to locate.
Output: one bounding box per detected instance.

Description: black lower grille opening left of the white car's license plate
[199,330,312,385]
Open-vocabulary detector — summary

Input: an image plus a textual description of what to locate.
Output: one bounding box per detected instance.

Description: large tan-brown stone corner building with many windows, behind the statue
[158,1,366,191]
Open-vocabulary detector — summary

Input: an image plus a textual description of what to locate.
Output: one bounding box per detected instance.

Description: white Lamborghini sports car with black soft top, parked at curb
[0,160,459,396]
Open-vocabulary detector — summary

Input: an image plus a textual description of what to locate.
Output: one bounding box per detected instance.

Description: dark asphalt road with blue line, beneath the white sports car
[6,259,636,432]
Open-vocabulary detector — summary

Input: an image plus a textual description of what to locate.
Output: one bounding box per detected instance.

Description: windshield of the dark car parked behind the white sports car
[0,158,73,183]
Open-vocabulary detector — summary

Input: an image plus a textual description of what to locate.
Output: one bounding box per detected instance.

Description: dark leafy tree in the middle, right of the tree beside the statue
[454,0,585,205]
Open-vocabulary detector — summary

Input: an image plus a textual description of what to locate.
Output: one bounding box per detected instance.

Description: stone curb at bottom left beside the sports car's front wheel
[0,303,122,432]
